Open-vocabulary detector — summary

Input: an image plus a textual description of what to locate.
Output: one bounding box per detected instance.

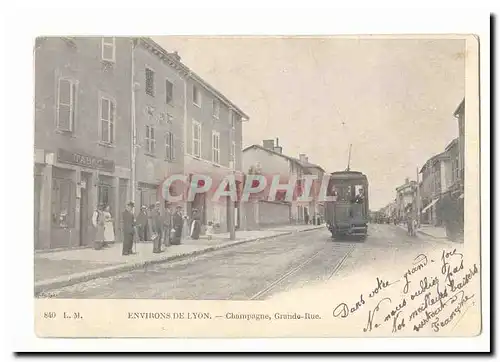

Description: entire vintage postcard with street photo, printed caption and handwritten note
[33,34,482,338]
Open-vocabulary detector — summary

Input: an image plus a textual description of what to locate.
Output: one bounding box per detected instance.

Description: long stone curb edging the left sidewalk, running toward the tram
[34,225,321,297]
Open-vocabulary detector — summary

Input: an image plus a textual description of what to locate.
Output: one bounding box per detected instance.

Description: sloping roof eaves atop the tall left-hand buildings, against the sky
[140,37,250,121]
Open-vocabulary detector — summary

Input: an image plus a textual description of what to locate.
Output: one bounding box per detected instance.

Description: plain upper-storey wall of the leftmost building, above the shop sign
[35,37,131,168]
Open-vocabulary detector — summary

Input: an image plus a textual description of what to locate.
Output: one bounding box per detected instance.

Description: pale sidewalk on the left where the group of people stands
[35,225,324,294]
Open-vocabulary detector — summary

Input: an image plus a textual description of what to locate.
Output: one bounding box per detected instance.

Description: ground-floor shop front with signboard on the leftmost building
[35,149,128,249]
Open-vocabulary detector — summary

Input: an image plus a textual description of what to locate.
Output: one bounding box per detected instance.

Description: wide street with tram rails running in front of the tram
[47,224,458,300]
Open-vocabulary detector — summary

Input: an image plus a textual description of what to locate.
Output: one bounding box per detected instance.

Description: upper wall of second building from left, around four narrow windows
[134,45,185,203]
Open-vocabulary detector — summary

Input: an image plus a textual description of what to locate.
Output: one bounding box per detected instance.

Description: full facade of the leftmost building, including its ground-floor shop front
[35,37,131,249]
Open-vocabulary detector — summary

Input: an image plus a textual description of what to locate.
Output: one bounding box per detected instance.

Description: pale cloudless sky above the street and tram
[153,37,465,210]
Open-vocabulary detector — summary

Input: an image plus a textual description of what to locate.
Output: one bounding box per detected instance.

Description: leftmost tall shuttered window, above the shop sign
[57,78,77,132]
